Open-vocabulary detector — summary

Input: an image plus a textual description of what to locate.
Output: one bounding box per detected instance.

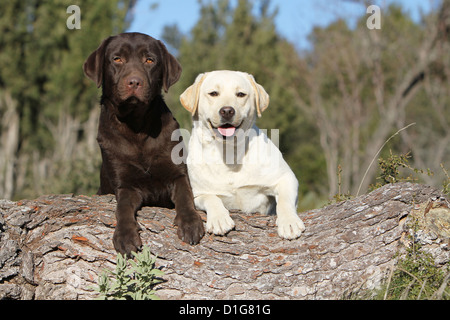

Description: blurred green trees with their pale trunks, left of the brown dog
[0,0,136,198]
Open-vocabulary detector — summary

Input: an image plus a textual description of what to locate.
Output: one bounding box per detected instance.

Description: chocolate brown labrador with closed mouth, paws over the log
[84,33,204,257]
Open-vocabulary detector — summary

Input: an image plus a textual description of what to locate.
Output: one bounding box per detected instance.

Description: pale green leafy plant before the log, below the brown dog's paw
[94,247,164,300]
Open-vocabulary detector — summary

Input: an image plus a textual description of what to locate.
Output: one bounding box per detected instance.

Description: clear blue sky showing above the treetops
[128,0,439,49]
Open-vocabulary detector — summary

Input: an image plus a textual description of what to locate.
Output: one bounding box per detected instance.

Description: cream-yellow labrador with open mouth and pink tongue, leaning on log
[180,71,305,239]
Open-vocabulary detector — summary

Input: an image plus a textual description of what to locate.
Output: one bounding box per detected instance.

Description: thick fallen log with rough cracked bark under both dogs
[0,183,450,299]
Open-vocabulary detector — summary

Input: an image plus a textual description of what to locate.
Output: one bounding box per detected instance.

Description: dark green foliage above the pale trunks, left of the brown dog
[0,0,132,150]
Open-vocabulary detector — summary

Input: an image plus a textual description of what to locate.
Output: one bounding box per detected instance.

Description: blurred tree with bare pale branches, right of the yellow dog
[278,2,450,196]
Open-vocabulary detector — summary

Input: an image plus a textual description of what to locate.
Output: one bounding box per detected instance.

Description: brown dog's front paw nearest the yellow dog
[174,211,205,245]
